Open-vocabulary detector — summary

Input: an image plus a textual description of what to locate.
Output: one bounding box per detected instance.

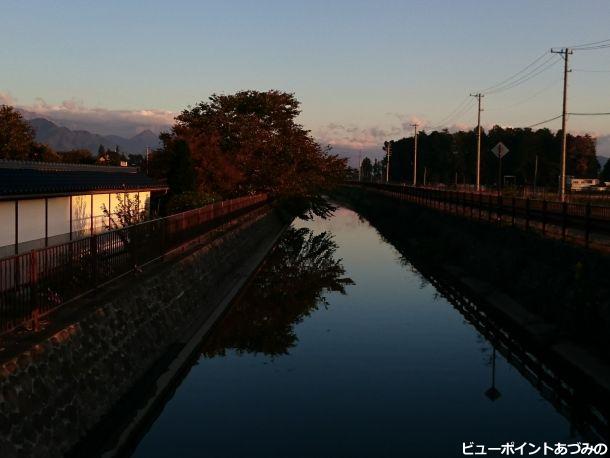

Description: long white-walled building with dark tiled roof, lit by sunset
[0,160,167,257]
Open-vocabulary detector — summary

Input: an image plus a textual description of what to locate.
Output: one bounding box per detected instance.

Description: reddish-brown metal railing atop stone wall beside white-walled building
[0,194,268,334]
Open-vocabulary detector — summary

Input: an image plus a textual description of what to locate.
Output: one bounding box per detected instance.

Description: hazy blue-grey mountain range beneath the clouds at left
[29,118,159,154]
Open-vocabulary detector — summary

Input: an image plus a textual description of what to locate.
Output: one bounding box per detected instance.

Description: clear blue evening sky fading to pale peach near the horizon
[0,0,610,155]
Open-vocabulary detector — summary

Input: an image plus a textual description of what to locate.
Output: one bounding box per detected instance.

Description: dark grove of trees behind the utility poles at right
[380,126,599,187]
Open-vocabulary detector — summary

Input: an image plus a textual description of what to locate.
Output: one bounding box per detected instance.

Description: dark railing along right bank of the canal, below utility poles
[348,182,610,251]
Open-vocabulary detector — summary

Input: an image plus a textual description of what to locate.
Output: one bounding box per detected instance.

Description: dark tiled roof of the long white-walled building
[0,167,167,199]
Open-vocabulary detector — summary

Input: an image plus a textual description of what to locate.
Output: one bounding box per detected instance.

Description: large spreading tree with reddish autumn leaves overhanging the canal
[155,91,347,216]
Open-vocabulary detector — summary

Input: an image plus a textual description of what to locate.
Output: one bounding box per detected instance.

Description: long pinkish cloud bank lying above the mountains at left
[0,93,177,137]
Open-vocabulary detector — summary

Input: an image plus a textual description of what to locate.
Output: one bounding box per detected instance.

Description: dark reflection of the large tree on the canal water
[203,228,353,357]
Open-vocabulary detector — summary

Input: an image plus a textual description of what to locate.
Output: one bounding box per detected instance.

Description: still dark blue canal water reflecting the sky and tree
[135,208,580,457]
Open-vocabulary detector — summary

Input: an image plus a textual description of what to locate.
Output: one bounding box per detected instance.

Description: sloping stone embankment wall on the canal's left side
[0,210,286,458]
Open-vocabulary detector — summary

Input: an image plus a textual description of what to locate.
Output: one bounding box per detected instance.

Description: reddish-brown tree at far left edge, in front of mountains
[0,105,35,160]
